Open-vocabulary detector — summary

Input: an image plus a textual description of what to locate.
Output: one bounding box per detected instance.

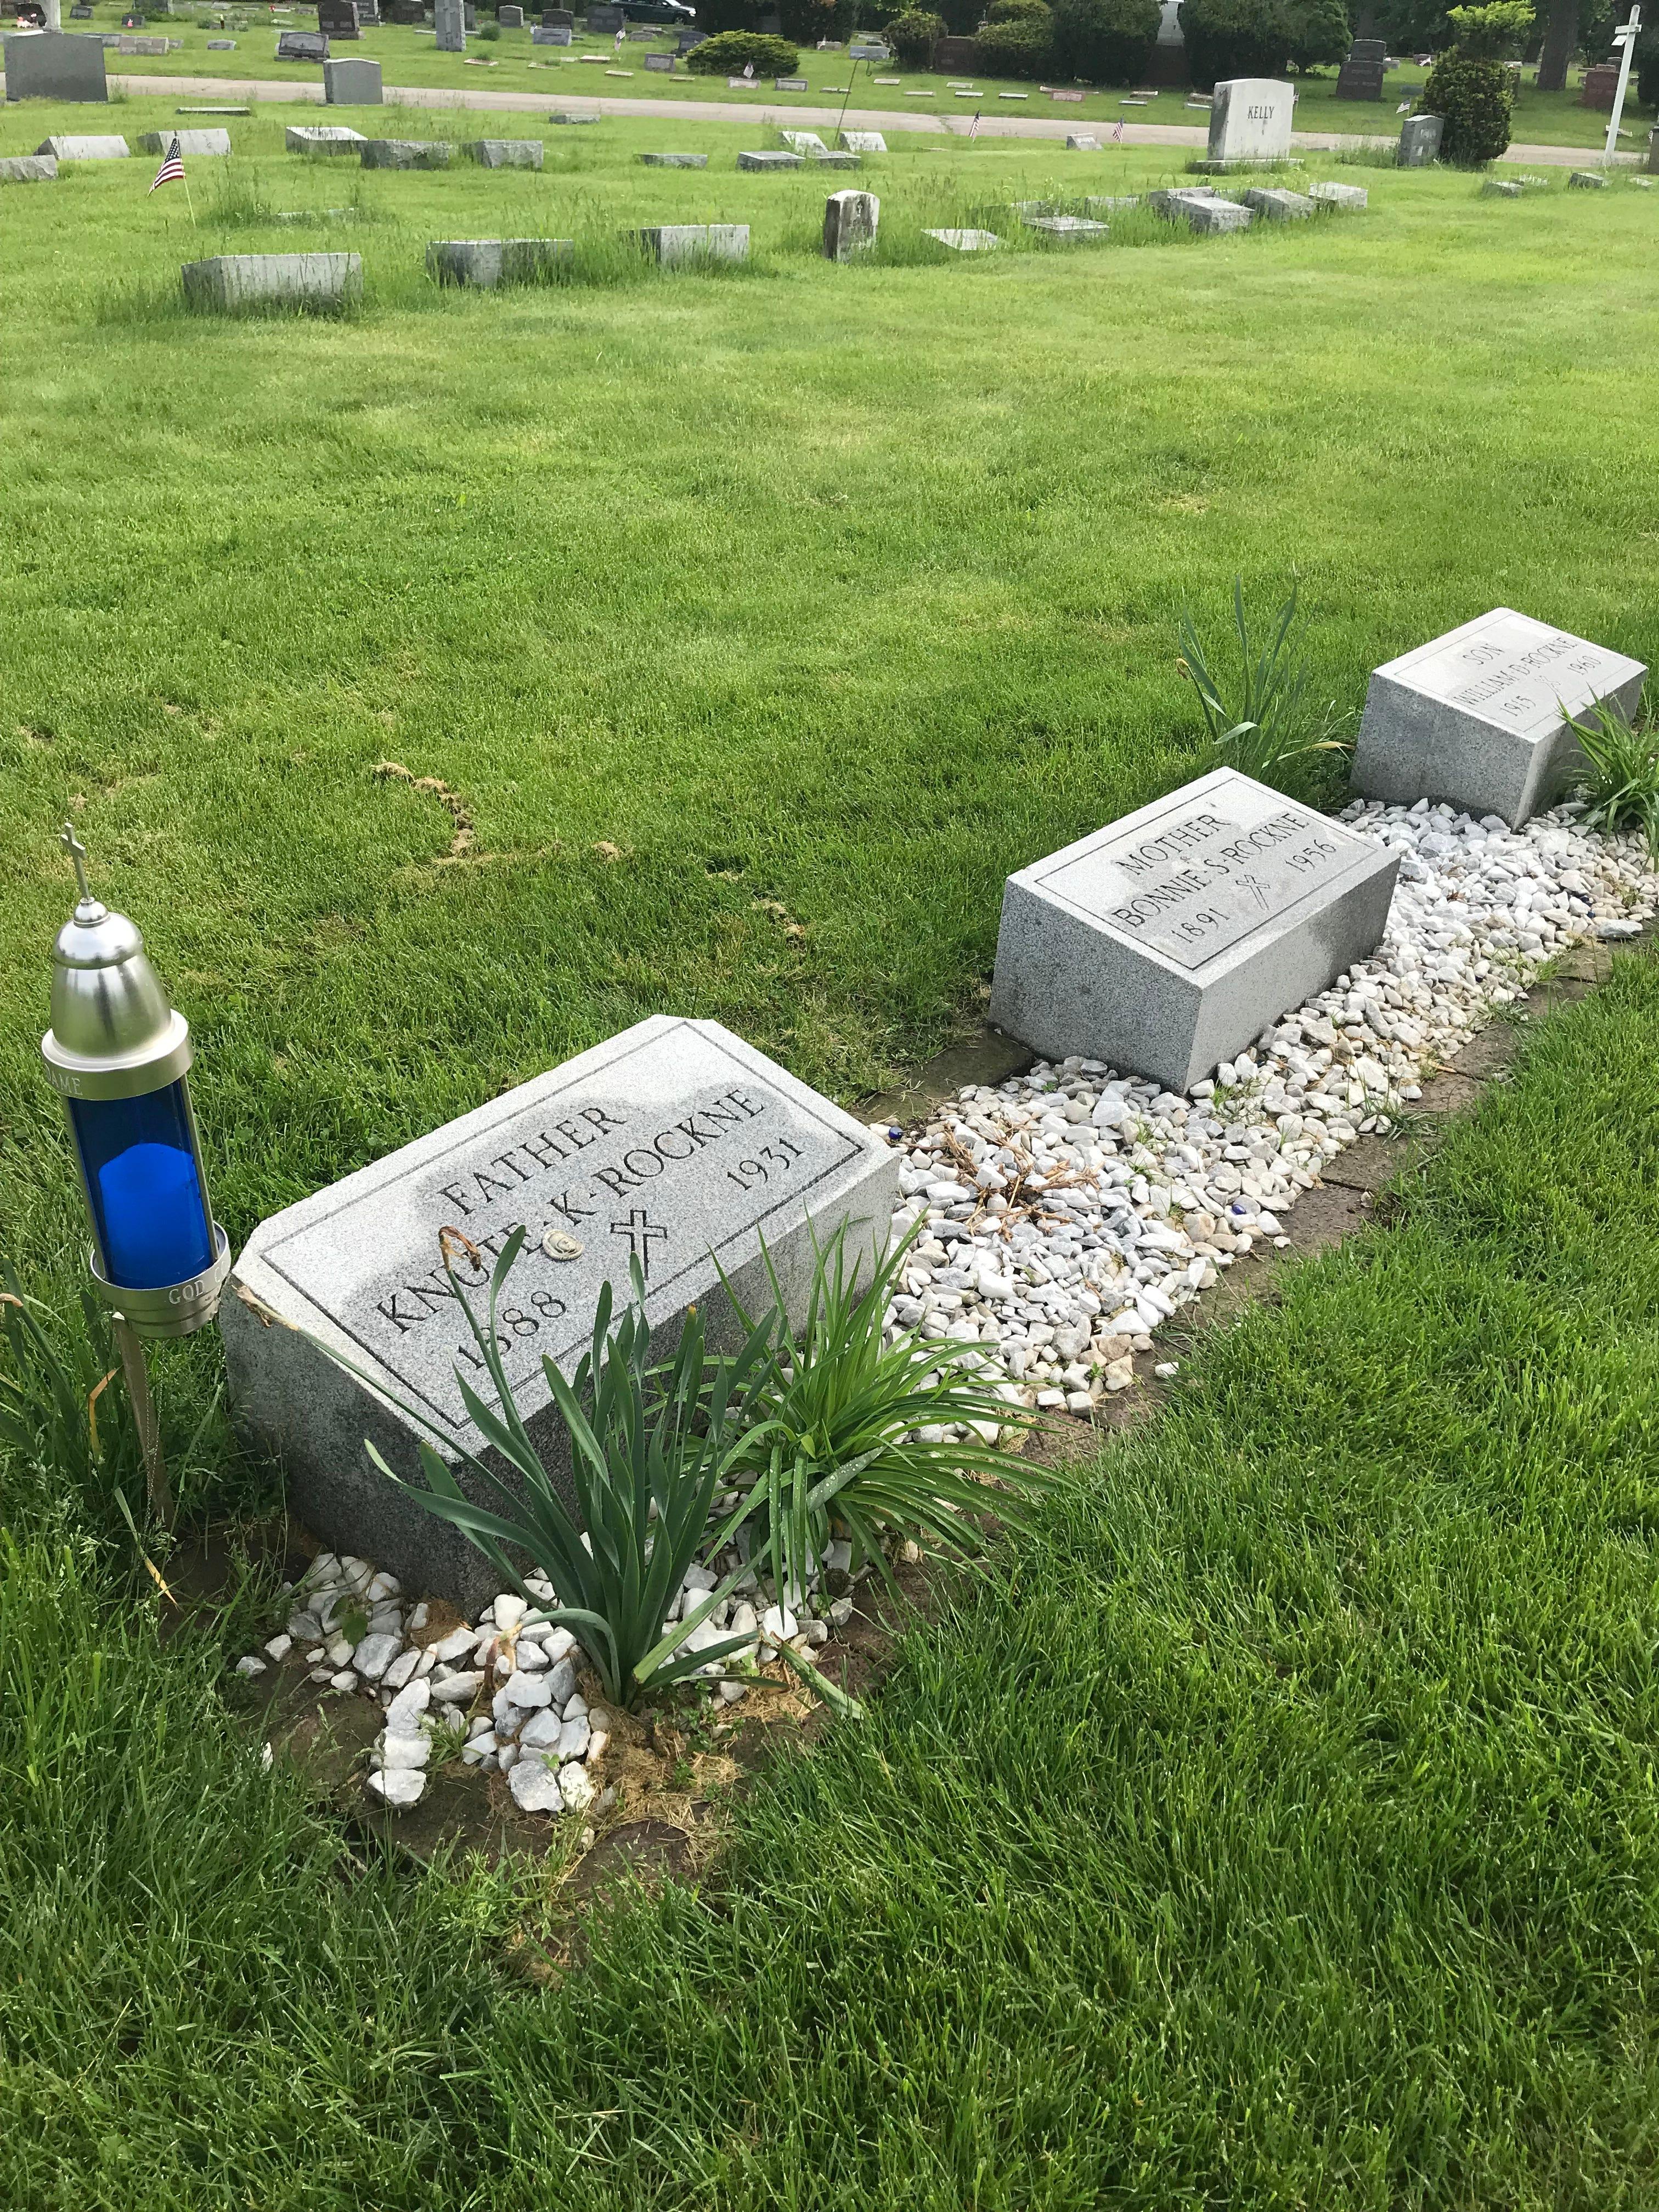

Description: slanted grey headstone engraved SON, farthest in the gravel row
[1354,606,1648,827]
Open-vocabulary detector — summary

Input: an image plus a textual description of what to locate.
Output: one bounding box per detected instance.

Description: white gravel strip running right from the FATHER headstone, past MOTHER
[874,801,1659,1434]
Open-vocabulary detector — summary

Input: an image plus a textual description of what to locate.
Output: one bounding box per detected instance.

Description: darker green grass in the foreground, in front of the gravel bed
[0,942,1659,2212]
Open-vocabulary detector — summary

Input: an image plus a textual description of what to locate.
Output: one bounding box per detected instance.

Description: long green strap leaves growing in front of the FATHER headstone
[325,1228,1051,1717]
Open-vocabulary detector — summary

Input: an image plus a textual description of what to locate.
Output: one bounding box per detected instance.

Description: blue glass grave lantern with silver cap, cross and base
[40,823,230,1336]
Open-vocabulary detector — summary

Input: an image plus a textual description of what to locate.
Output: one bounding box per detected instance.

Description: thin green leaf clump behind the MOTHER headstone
[1175,575,1352,789]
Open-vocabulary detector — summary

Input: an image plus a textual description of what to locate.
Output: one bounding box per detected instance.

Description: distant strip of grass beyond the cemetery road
[29,0,1652,153]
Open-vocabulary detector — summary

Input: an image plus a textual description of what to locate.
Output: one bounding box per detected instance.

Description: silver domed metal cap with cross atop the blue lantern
[40,823,190,1099]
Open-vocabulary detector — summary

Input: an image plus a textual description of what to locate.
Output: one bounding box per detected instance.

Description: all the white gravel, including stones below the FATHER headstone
[236,801,1659,1814]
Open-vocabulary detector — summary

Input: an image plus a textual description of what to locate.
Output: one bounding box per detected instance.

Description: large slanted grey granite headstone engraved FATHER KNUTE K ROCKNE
[221,1015,898,1606]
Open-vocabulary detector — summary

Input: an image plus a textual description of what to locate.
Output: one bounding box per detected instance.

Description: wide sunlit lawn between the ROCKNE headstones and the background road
[0,99,1659,1336]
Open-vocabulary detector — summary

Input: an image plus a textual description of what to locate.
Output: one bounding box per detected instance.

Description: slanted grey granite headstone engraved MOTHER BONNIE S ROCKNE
[991,768,1400,1091]
